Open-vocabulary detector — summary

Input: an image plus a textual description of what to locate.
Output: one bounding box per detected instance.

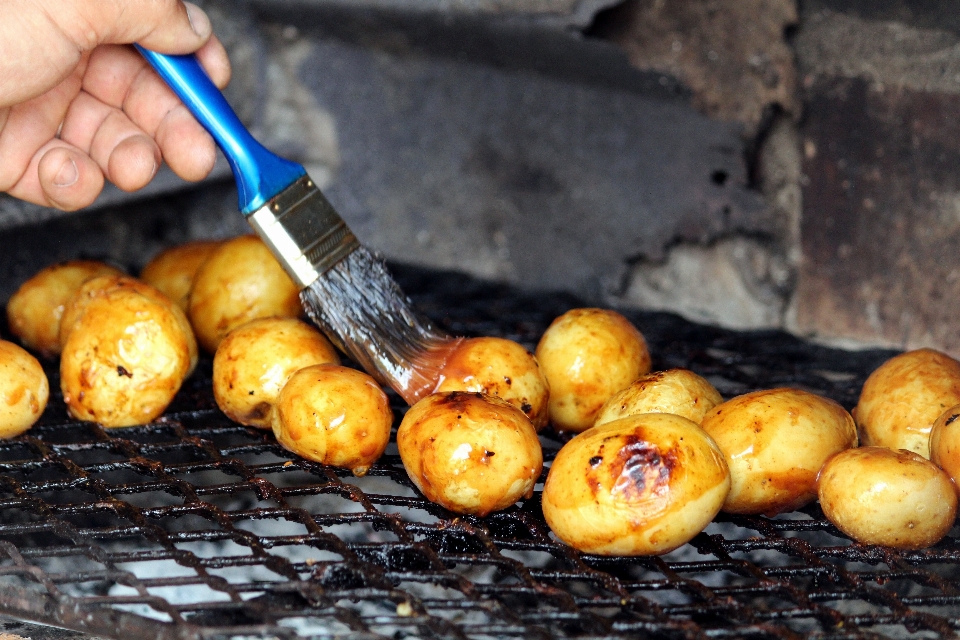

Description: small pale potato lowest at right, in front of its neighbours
[817,447,957,549]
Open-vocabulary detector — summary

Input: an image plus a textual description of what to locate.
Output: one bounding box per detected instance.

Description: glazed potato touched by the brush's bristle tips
[434,338,550,431]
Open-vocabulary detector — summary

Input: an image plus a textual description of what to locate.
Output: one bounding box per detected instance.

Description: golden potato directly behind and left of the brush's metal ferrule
[187,236,302,353]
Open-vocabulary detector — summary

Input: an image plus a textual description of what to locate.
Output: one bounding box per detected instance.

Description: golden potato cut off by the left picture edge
[0,340,50,438]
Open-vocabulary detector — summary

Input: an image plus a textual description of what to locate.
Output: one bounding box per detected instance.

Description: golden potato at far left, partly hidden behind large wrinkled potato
[7,260,123,356]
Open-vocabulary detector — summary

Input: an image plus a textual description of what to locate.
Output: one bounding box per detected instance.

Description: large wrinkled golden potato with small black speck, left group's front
[60,276,196,427]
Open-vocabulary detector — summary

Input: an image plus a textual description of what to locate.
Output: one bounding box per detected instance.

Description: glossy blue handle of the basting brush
[137,45,307,214]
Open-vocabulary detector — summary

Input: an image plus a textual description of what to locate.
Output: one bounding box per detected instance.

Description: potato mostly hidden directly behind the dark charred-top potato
[594,369,723,426]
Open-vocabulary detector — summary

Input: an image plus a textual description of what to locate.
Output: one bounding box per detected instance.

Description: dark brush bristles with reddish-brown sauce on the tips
[300,247,459,404]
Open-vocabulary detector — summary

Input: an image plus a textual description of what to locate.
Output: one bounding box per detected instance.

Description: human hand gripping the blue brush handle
[0,0,230,210]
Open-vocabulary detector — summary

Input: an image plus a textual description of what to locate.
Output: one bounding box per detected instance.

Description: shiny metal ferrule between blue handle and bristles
[247,176,360,288]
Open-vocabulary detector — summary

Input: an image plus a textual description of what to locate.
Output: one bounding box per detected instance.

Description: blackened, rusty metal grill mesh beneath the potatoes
[0,262,960,640]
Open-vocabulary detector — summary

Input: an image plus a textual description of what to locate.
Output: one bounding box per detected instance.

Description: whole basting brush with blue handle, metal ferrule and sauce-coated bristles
[137,47,459,404]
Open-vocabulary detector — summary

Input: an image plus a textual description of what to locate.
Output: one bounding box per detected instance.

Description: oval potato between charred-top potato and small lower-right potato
[700,389,857,515]
